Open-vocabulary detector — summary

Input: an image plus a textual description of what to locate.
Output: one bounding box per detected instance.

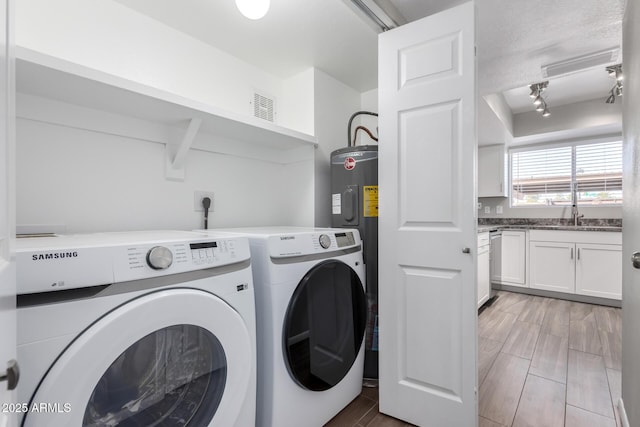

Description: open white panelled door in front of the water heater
[378,2,477,427]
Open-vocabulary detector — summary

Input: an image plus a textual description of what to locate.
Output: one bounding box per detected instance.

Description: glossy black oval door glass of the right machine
[283,260,367,391]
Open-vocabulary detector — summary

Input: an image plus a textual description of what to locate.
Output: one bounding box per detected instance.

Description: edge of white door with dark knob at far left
[0,0,17,427]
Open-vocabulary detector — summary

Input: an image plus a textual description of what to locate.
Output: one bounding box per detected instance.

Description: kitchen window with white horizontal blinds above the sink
[510,141,622,206]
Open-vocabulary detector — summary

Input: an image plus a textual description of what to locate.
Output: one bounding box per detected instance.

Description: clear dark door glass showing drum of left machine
[82,325,227,426]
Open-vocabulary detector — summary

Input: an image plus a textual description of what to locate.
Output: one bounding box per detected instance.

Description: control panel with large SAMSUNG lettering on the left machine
[16,231,250,294]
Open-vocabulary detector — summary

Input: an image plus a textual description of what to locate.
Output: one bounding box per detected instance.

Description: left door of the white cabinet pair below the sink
[529,242,575,293]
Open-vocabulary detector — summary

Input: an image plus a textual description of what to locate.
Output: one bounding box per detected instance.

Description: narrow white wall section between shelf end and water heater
[314,69,360,227]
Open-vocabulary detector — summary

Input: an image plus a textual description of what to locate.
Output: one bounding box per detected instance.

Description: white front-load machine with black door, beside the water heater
[196,227,367,427]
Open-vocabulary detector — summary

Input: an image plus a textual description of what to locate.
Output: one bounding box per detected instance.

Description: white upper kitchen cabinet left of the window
[478,144,509,197]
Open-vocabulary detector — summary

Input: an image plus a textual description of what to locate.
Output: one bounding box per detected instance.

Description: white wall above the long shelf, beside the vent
[16,0,313,133]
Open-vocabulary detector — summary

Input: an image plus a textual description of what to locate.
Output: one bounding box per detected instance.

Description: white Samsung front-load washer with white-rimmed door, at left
[17,231,256,427]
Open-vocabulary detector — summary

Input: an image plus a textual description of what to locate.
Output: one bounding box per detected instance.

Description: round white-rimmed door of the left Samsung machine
[23,290,255,427]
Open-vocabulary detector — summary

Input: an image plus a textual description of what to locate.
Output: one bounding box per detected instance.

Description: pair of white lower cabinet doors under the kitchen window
[529,230,622,300]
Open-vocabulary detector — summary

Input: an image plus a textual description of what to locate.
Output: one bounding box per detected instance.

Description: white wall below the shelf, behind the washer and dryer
[16,96,314,233]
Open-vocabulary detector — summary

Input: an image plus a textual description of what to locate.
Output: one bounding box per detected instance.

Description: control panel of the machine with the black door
[269,230,360,258]
